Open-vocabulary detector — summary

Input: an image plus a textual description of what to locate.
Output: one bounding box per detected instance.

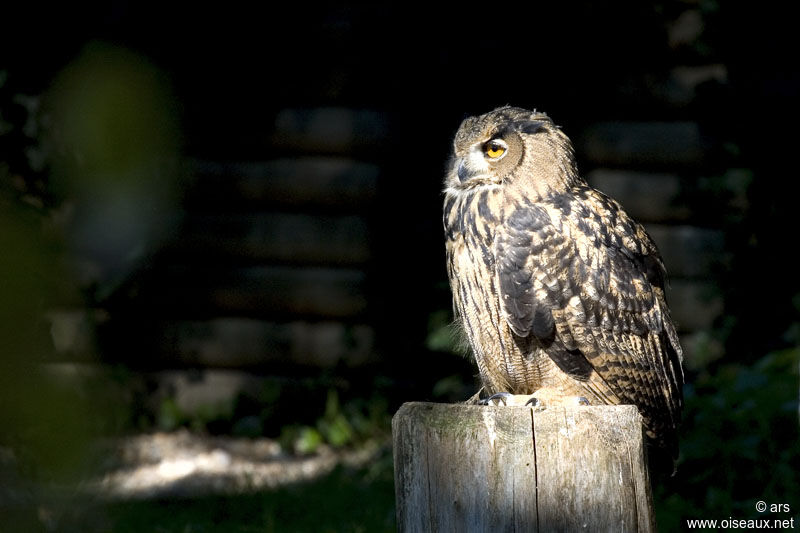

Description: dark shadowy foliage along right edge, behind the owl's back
[654,2,800,531]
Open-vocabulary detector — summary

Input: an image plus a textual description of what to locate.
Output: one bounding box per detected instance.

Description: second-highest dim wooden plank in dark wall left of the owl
[187,156,380,212]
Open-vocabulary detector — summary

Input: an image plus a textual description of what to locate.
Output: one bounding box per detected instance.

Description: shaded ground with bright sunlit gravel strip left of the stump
[0,431,395,533]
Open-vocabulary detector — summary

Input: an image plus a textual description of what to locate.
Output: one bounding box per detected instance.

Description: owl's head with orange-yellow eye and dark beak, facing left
[445,106,580,196]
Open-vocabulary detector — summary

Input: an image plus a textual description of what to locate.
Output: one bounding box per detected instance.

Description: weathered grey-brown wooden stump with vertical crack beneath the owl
[392,402,655,532]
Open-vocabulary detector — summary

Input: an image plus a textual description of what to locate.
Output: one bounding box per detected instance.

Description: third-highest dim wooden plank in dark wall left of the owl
[170,213,371,266]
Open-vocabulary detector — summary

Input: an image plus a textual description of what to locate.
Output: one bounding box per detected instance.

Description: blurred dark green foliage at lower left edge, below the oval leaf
[0,168,99,531]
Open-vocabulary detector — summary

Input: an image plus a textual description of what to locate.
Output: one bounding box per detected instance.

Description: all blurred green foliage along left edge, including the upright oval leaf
[0,41,180,531]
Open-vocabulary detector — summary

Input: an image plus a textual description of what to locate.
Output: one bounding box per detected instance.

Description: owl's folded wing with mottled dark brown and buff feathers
[495,187,683,444]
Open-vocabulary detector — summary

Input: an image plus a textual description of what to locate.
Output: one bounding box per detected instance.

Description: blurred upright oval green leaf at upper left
[41,42,182,304]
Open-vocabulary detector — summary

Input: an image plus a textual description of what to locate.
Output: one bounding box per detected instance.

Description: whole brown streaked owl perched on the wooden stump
[443,107,683,458]
